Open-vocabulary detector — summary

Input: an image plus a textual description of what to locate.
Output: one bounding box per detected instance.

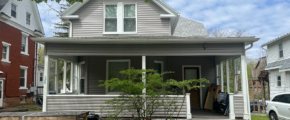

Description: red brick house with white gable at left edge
[0,0,44,107]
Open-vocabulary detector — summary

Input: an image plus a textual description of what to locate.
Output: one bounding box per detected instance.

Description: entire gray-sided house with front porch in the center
[32,0,259,119]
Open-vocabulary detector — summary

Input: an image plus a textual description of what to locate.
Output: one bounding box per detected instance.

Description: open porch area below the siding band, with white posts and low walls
[44,55,247,119]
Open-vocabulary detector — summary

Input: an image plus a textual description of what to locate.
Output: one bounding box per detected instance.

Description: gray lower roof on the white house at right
[265,58,290,71]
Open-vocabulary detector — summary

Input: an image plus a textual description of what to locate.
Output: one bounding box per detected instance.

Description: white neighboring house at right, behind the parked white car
[261,33,290,98]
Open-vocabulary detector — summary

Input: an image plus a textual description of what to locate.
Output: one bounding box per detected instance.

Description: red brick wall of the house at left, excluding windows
[0,22,35,105]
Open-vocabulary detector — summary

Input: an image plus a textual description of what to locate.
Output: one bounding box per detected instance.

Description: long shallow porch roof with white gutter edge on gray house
[32,36,260,45]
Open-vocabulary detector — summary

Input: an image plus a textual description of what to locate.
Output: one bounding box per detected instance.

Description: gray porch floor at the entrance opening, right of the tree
[191,109,229,120]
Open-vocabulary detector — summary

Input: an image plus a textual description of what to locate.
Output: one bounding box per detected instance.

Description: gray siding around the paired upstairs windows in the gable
[71,0,171,37]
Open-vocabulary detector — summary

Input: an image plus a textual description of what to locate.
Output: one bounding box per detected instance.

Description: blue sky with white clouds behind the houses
[38,0,290,59]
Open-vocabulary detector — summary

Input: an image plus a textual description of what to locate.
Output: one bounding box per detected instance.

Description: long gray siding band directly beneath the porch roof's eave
[46,43,244,56]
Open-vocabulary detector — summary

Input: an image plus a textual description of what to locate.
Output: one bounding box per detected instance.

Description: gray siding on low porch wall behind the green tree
[47,95,186,117]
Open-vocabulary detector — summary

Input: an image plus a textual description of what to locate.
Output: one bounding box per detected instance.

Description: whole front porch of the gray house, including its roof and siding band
[33,36,258,119]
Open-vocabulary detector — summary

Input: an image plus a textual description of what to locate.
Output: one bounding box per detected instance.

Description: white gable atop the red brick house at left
[0,0,44,36]
